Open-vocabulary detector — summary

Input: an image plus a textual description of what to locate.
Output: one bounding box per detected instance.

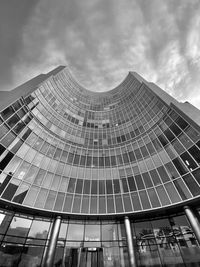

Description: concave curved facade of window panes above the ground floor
[0,71,200,214]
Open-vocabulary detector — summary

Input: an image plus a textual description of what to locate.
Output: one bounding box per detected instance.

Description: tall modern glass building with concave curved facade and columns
[0,66,200,267]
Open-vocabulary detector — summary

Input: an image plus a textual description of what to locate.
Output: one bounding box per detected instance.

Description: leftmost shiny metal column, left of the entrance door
[44,216,61,267]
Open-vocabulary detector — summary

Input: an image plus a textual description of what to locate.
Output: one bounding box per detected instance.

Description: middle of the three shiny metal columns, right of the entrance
[124,217,137,267]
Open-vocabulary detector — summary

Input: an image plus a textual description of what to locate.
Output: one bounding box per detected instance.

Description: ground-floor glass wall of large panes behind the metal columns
[0,210,200,267]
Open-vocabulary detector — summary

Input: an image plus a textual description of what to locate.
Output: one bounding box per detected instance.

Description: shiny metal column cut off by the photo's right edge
[184,206,200,245]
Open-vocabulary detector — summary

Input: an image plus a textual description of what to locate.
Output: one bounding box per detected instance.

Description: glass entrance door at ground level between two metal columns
[79,248,104,267]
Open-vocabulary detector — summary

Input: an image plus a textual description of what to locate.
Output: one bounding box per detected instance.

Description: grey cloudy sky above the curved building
[0,0,200,108]
